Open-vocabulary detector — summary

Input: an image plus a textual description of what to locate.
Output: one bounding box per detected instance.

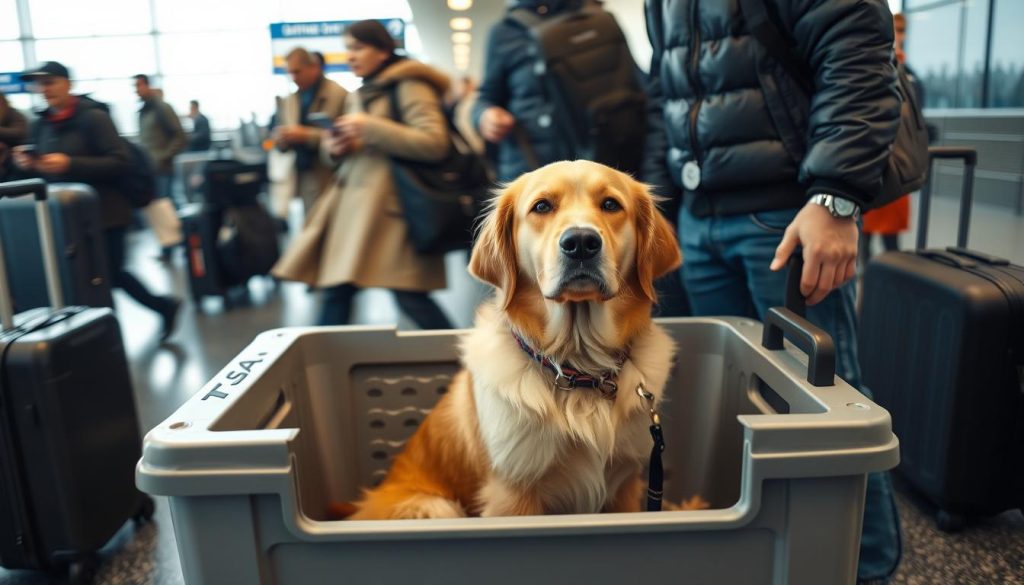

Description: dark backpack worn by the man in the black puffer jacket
[739,0,929,211]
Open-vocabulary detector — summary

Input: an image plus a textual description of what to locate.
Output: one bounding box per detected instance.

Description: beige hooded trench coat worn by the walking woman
[273,59,451,291]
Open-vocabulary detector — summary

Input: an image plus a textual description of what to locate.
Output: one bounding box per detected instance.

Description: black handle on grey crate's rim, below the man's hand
[761,256,836,386]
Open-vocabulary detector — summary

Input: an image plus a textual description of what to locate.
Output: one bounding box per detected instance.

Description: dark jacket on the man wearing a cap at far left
[31,97,132,227]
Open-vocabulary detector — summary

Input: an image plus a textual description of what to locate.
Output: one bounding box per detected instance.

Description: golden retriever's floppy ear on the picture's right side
[634,182,683,302]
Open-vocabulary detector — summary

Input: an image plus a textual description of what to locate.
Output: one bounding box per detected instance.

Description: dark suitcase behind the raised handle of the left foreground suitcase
[0,183,114,312]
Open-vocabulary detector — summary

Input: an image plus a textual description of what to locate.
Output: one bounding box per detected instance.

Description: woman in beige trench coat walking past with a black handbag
[272,20,452,329]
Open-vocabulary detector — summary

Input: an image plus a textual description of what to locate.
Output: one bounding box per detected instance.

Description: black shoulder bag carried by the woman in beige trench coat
[389,85,492,254]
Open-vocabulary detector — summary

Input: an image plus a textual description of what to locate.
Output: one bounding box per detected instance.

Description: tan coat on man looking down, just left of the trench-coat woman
[271,78,348,217]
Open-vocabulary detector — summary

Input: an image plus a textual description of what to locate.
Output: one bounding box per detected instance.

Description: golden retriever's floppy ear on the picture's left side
[469,183,519,308]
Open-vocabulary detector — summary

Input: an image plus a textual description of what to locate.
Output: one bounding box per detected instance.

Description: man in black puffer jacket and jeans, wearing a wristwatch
[643,0,900,581]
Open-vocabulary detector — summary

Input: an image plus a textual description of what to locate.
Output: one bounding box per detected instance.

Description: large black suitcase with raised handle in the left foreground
[0,179,153,585]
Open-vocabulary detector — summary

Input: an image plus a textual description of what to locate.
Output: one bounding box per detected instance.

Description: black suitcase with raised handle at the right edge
[859,148,1024,531]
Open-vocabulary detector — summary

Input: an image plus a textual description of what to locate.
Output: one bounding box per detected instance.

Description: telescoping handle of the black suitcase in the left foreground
[0,178,63,330]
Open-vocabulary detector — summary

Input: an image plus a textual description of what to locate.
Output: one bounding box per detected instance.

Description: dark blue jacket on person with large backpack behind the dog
[472,0,580,181]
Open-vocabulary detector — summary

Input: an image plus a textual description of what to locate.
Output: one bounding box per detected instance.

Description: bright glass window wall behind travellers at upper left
[8,0,415,134]
